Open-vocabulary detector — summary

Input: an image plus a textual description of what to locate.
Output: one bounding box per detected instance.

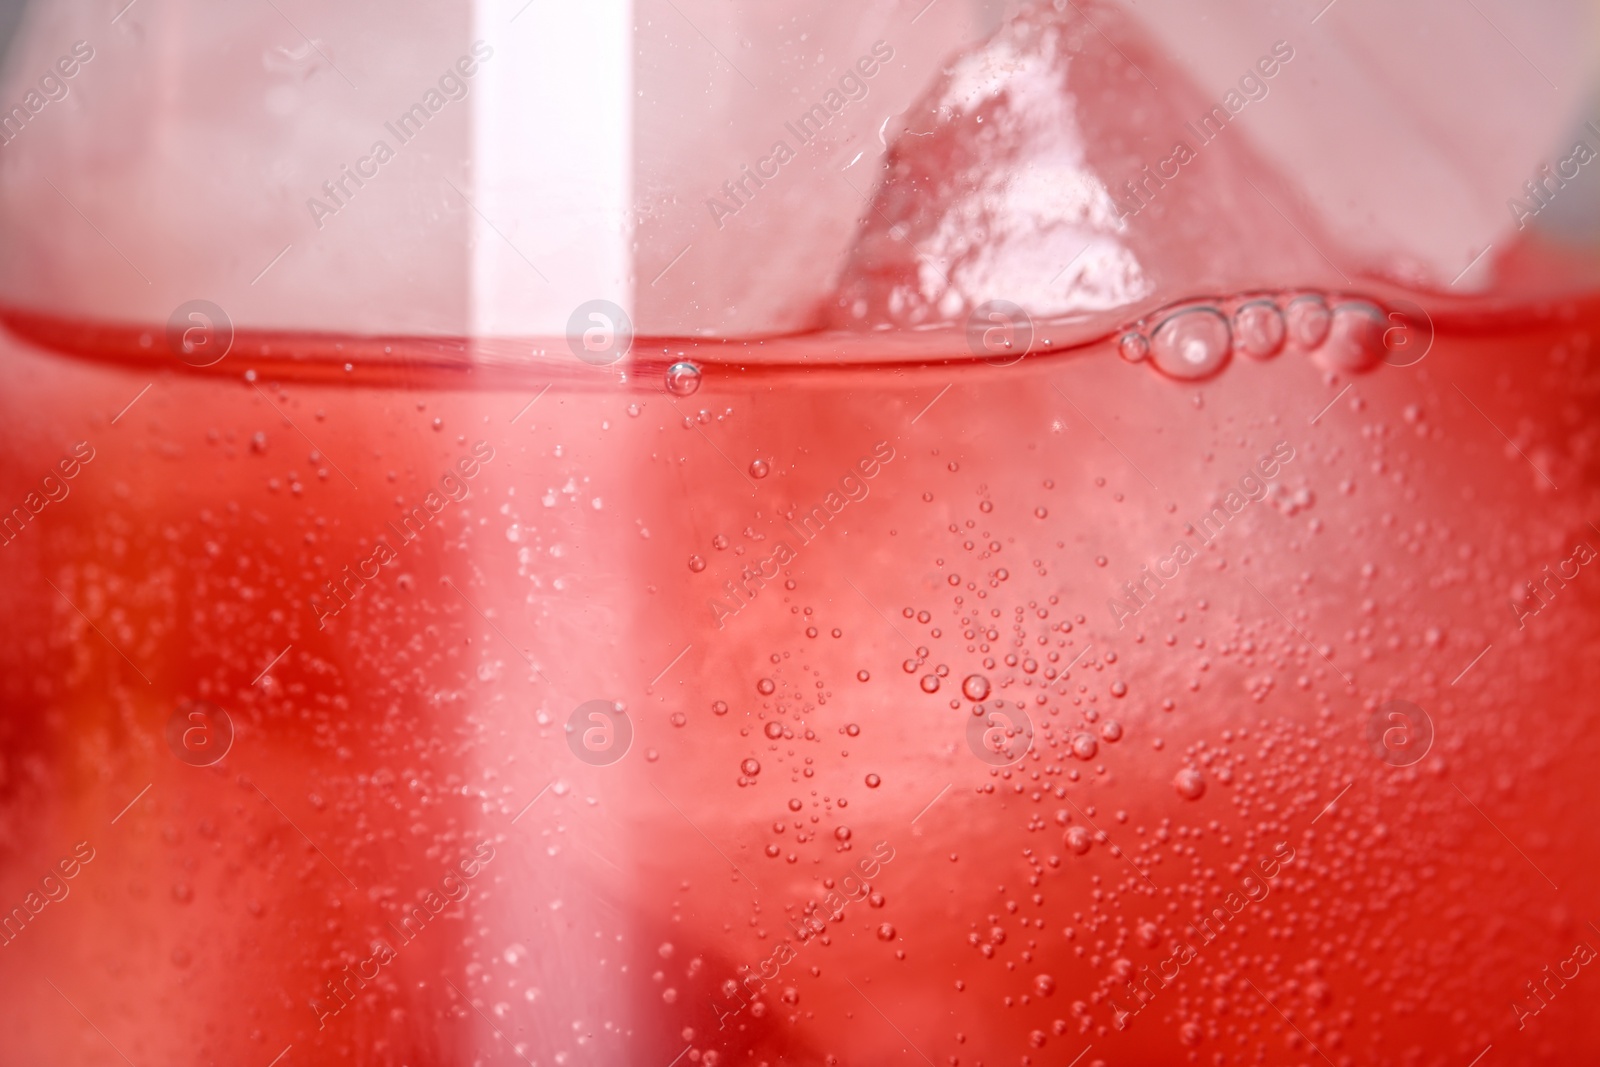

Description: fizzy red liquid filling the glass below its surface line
[0,306,1600,1067]
